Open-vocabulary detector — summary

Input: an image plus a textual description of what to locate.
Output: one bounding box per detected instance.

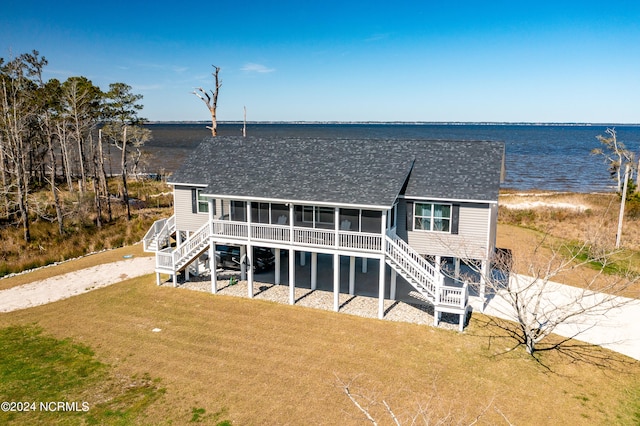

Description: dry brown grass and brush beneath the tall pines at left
[0,180,172,277]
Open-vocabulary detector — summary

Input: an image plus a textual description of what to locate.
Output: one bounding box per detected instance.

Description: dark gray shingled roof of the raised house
[169,137,503,206]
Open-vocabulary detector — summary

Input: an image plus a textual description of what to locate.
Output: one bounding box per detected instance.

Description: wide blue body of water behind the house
[145,123,640,192]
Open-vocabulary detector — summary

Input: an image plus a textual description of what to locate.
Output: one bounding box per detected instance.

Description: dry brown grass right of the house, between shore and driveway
[497,192,640,298]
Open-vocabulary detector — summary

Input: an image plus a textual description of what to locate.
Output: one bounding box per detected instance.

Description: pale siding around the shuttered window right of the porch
[397,202,495,259]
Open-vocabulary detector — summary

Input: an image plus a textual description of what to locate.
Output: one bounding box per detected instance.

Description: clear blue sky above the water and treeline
[0,0,640,123]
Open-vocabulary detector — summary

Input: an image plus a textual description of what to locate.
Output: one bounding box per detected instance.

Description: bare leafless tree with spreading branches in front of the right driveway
[450,230,640,356]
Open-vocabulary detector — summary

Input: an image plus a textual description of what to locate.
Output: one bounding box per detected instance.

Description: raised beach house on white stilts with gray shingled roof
[144,137,504,330]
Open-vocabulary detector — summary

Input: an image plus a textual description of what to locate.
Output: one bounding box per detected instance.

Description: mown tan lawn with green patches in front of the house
[0,276,640,425]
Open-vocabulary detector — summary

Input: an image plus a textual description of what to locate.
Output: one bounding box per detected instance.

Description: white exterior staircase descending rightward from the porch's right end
[385,232,470,331]
